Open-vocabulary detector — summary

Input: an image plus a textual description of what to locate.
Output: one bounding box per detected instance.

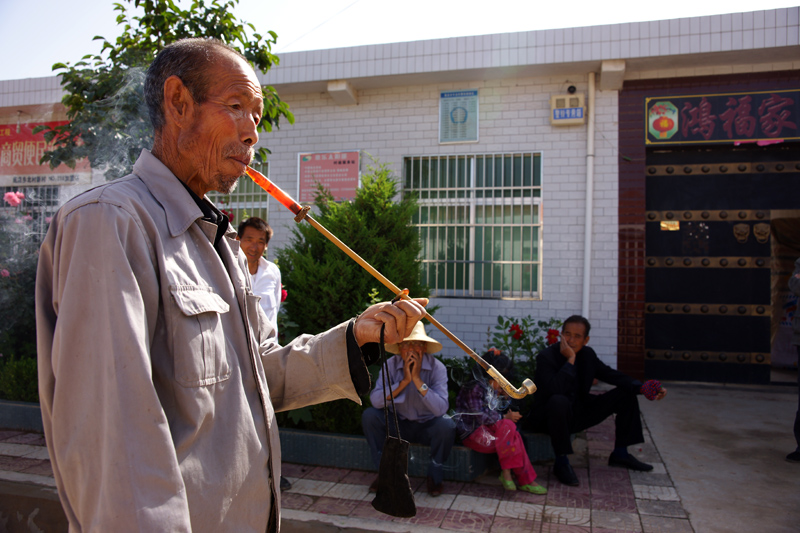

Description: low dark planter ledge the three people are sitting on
[280,429,555,481]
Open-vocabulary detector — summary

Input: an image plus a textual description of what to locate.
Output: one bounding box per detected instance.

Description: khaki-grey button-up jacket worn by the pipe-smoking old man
[36,151,359,533]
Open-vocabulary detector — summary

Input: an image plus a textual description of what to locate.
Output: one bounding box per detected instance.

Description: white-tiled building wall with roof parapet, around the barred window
[0,8,800,382]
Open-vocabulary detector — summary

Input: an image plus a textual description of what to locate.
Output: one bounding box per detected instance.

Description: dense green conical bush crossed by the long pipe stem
[278,161,429,334]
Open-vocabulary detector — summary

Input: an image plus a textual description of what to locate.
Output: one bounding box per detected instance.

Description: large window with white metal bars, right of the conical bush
[403,152,542,299]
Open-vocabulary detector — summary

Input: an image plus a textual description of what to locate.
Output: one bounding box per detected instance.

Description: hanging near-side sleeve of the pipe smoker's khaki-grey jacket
[36,203,191,532]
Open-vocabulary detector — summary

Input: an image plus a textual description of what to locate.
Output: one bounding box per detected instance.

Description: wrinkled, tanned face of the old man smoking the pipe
[178,52,264,194]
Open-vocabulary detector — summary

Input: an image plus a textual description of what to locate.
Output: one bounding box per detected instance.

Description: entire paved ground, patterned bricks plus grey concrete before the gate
[0,384,800,533]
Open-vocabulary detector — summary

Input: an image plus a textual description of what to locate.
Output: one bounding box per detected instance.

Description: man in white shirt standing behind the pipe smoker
[236,217,292,490]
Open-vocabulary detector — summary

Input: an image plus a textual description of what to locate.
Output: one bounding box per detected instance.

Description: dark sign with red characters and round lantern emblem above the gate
[645,90,800,144]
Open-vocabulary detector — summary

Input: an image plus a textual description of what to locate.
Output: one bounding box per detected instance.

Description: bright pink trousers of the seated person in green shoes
[464,418,536,485]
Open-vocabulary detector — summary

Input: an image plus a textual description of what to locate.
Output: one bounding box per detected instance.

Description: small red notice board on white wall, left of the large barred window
[298,152,360,203]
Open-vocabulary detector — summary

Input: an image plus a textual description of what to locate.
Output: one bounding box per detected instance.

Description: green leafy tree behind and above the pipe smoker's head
[36,0,294,179]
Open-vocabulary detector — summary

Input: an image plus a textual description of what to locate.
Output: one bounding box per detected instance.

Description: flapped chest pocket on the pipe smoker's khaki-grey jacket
[170,285,231,387]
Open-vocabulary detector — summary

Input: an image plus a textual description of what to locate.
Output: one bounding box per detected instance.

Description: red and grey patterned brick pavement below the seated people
[0,420,694,533]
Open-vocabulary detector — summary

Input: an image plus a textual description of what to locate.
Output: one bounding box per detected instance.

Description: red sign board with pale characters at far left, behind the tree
[0,121,91,186]
